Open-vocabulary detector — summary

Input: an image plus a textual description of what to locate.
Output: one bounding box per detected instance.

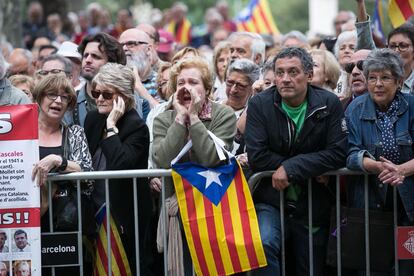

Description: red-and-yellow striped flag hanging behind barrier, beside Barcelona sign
[93,205,132,276]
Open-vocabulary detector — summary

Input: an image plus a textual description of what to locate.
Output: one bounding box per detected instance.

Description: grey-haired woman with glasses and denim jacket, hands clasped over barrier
[345,49,414,275]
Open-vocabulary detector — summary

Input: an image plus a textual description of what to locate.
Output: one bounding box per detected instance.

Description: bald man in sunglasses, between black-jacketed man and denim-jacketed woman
[341,50,371,111]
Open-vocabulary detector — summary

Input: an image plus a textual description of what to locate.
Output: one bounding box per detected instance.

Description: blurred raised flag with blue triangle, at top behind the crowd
[236,0,279,34]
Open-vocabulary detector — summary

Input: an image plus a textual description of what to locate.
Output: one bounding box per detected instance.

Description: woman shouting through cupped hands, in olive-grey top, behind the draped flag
[152,57,236,275]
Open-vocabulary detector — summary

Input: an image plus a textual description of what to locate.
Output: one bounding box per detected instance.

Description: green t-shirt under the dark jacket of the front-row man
[282,99,308,201]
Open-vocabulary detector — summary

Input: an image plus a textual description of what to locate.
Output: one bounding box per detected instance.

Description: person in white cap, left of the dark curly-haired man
[57,41,85,91]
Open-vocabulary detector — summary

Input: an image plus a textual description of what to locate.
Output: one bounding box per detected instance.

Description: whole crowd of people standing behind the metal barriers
[0,0,414,276]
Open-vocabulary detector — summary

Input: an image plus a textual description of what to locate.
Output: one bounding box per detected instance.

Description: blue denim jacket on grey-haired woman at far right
[345,92,414,221]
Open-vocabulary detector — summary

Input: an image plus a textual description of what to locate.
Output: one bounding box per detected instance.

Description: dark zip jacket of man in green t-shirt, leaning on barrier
[245,86,347,224]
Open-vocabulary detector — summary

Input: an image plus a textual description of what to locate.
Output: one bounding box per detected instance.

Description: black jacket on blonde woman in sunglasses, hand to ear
[85,109,152,272]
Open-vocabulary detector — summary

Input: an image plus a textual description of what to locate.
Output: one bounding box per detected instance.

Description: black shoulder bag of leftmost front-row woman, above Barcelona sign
[52,126,97,235]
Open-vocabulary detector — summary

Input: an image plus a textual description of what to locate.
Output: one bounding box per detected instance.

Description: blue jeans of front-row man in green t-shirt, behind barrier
[252,203,328,276]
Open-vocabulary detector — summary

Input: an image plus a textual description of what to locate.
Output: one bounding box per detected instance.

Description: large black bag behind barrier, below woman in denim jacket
[327,206,394,272]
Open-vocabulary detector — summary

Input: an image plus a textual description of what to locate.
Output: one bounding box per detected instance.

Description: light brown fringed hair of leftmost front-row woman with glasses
[32,75,76,110]
